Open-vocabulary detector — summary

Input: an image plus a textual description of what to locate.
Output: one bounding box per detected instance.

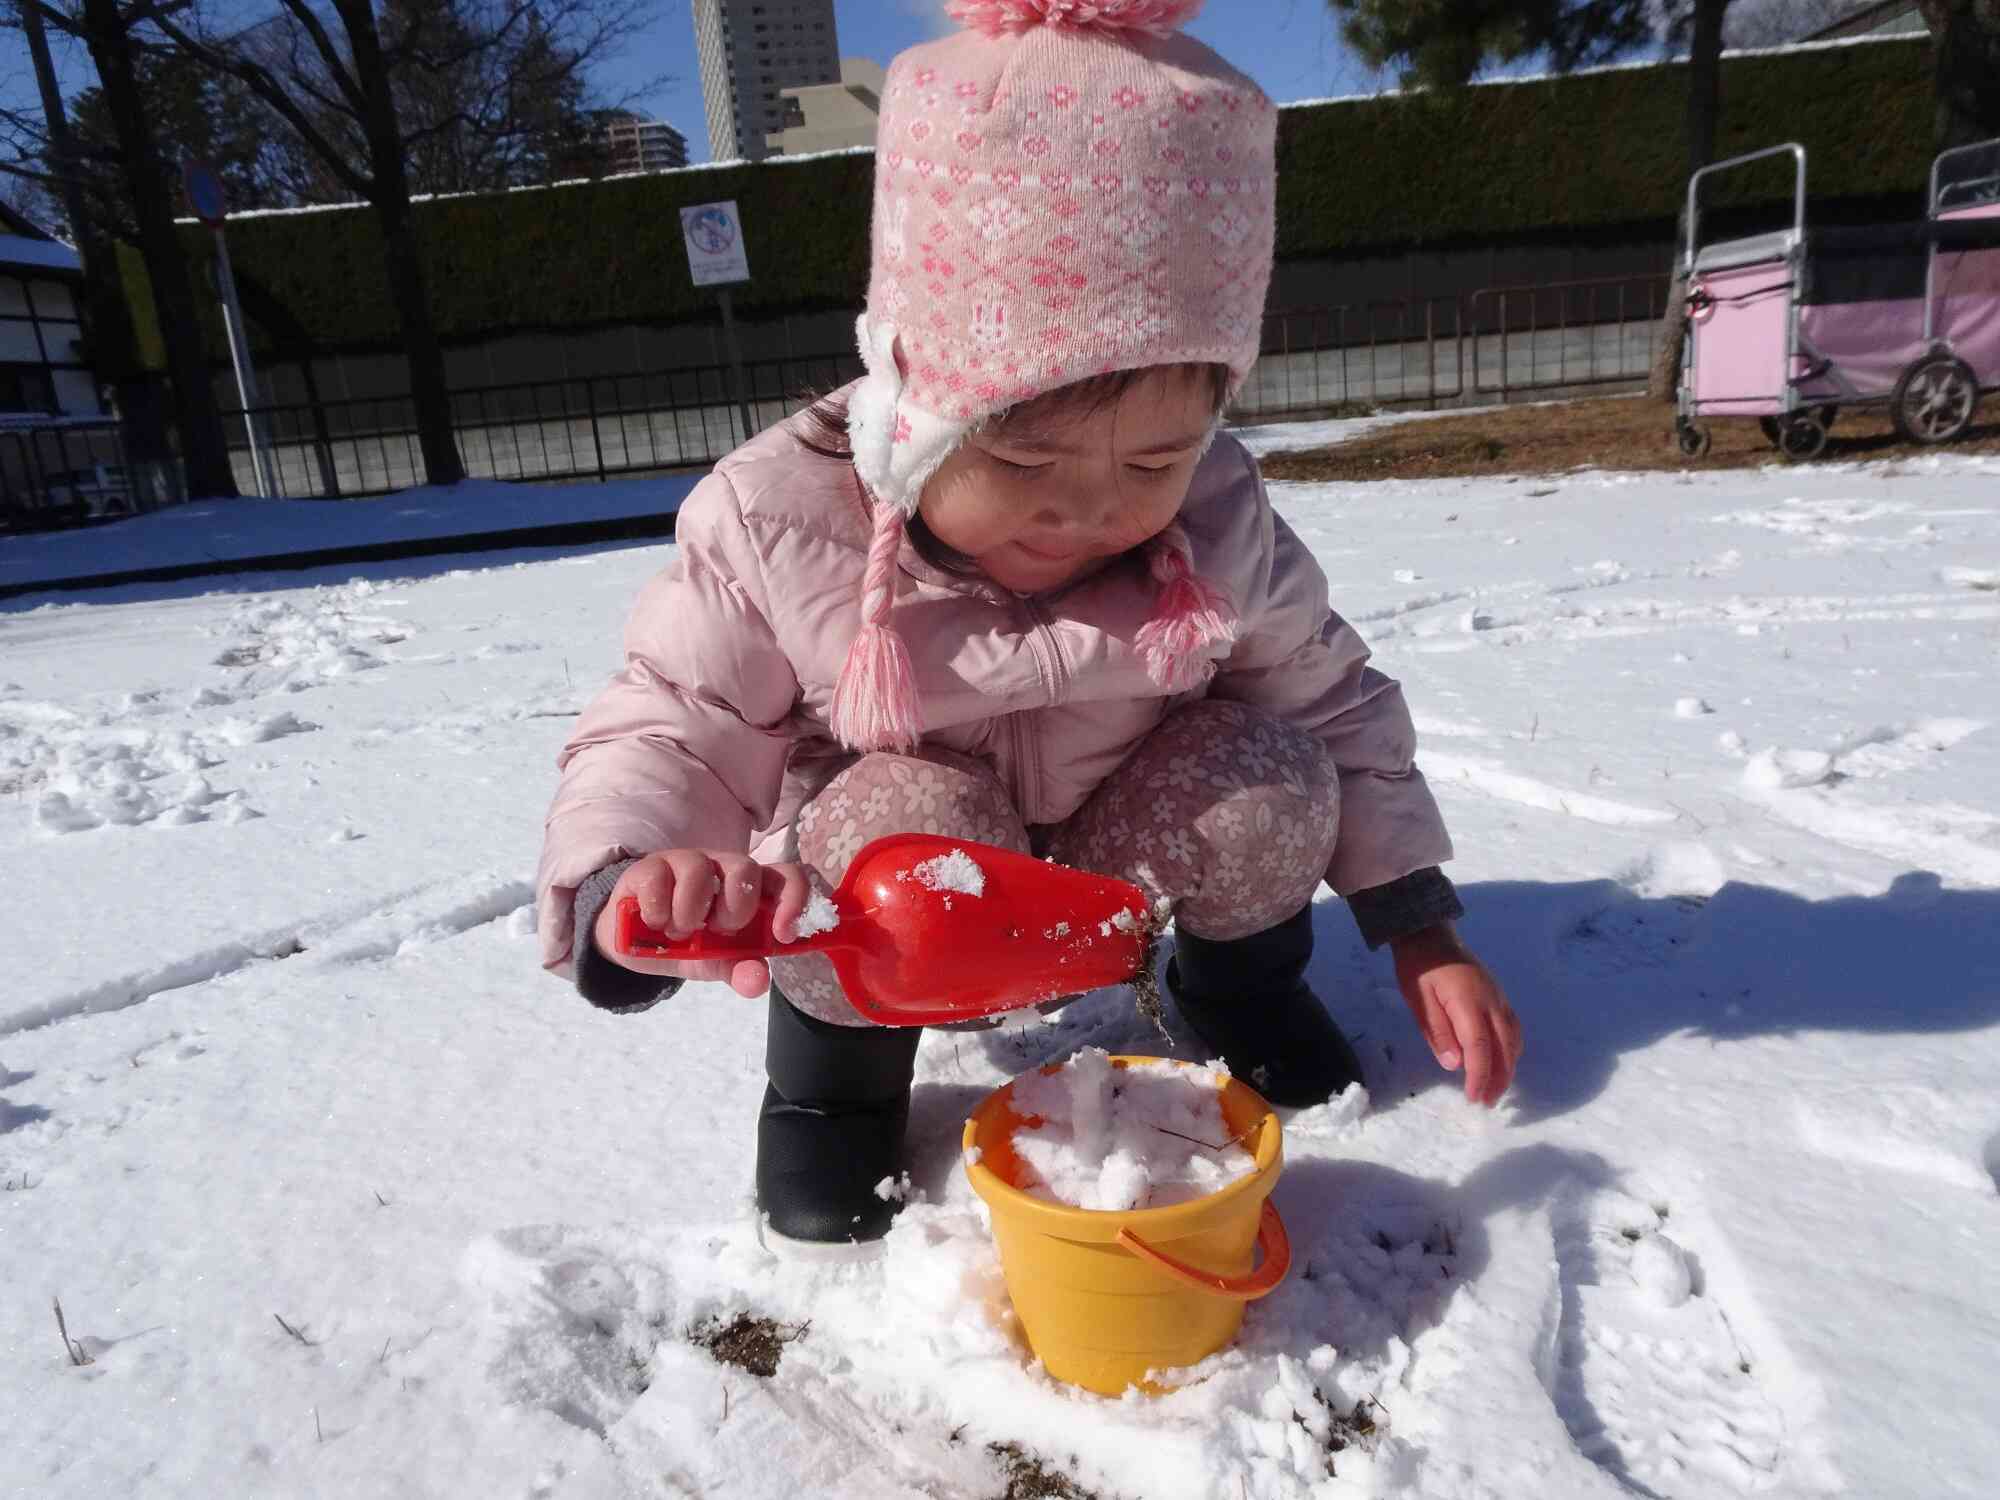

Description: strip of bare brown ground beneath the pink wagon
[1258,396,2000,482]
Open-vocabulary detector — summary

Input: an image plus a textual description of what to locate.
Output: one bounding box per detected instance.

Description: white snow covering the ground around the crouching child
[0,438,2000,1500]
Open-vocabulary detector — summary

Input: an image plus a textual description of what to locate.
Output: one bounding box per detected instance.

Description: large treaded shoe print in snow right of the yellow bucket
[1548,1192,1784,1500]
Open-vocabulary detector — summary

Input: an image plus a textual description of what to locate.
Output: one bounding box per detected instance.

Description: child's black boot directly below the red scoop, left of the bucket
[756,986,924,1246]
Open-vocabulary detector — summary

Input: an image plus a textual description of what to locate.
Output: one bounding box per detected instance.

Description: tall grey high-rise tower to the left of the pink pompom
[694,0,840,162]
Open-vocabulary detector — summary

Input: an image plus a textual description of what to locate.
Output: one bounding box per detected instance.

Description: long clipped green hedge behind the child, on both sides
[117,40,1932,370]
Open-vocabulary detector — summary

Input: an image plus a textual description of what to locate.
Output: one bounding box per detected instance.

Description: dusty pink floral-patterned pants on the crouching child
[770,700,1340,1026]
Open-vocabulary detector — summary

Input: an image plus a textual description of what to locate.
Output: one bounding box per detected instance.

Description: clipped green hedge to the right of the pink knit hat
[1278,38,1932,260]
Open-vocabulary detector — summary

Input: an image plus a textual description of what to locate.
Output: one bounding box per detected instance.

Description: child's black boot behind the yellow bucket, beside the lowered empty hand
[1166,904,1362,1106]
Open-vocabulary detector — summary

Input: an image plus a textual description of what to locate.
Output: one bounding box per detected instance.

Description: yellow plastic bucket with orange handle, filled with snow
[964,1058,1292,1396]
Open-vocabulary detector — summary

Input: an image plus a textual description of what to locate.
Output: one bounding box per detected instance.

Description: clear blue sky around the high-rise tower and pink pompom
[602,0,1390,162]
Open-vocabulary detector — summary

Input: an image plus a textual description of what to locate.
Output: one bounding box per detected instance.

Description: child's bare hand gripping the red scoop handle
[592,848,810,998]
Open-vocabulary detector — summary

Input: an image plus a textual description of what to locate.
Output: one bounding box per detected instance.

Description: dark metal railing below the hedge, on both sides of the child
[211,274,1668,498]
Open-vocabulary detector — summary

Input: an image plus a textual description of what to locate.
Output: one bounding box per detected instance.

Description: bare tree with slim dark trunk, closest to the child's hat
[154,0,644,484]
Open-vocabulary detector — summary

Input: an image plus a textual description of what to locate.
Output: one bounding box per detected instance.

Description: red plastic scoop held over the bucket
[618,834,1148,1026]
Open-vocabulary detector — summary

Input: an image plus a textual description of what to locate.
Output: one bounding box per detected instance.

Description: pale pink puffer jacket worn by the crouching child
[536,406,1452,976]
